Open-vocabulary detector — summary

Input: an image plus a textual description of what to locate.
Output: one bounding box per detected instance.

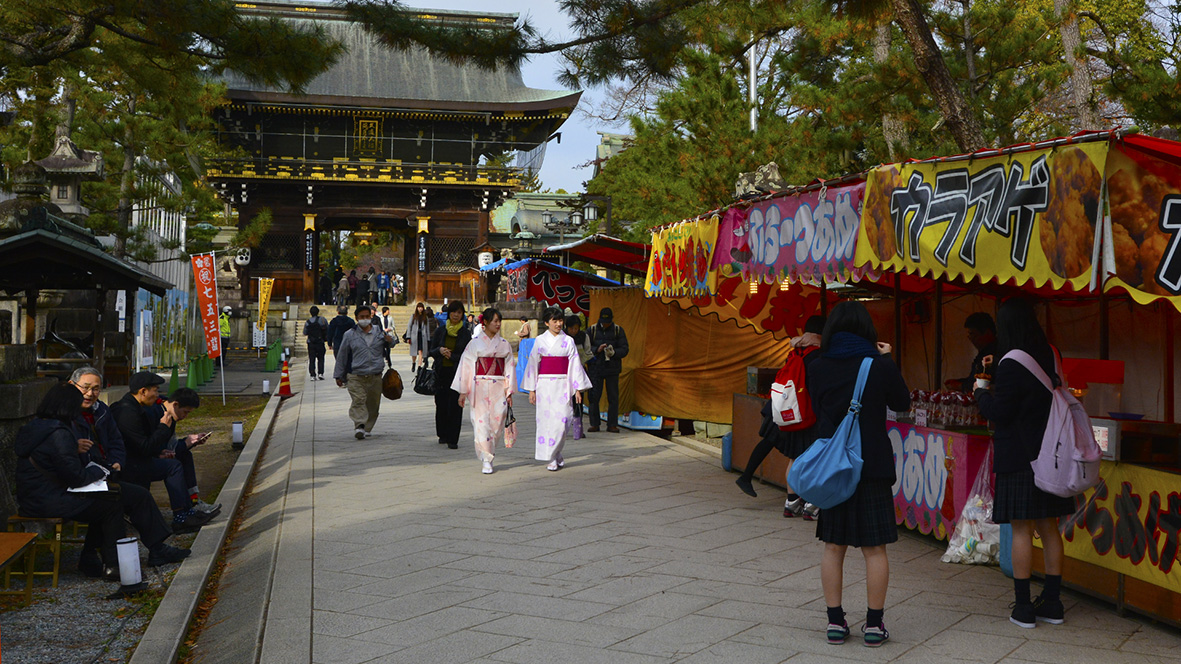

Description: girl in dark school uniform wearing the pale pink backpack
[976,299,1075,629]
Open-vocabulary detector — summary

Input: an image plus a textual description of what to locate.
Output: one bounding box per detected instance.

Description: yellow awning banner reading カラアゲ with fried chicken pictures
[854,142,1109,291]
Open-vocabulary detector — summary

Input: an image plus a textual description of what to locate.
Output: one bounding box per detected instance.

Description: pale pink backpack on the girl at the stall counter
[1000,351,1103,497]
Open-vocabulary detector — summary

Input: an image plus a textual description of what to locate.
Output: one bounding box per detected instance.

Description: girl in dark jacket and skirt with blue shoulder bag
[808,301,911,646]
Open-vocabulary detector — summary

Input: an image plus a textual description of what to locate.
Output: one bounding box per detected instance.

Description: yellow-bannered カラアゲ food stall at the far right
[855,132,1181,623]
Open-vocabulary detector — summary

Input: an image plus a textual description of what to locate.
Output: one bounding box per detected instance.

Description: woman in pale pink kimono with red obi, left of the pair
[451,307,516,475]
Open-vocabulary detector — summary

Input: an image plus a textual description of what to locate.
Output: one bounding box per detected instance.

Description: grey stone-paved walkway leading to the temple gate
[188,356,1181,664]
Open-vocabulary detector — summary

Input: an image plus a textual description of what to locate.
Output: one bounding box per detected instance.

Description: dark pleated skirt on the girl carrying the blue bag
[816,480,898,547]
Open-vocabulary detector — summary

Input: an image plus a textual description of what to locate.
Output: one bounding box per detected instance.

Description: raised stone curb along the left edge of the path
[129,378,288,664]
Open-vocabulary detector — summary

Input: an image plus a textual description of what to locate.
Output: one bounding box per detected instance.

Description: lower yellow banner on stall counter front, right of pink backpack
[1058,461,1181,592]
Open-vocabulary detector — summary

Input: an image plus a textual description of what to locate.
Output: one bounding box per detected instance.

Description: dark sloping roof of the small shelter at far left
[0,209,172,295]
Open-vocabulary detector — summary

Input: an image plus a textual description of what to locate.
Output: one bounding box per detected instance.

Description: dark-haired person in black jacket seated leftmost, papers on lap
[13,384,189,580]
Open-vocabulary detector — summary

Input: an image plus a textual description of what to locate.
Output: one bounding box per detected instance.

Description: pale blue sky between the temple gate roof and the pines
[405,0,604,193]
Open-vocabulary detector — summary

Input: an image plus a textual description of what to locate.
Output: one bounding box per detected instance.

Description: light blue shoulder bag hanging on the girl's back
[788,357,874,509]
